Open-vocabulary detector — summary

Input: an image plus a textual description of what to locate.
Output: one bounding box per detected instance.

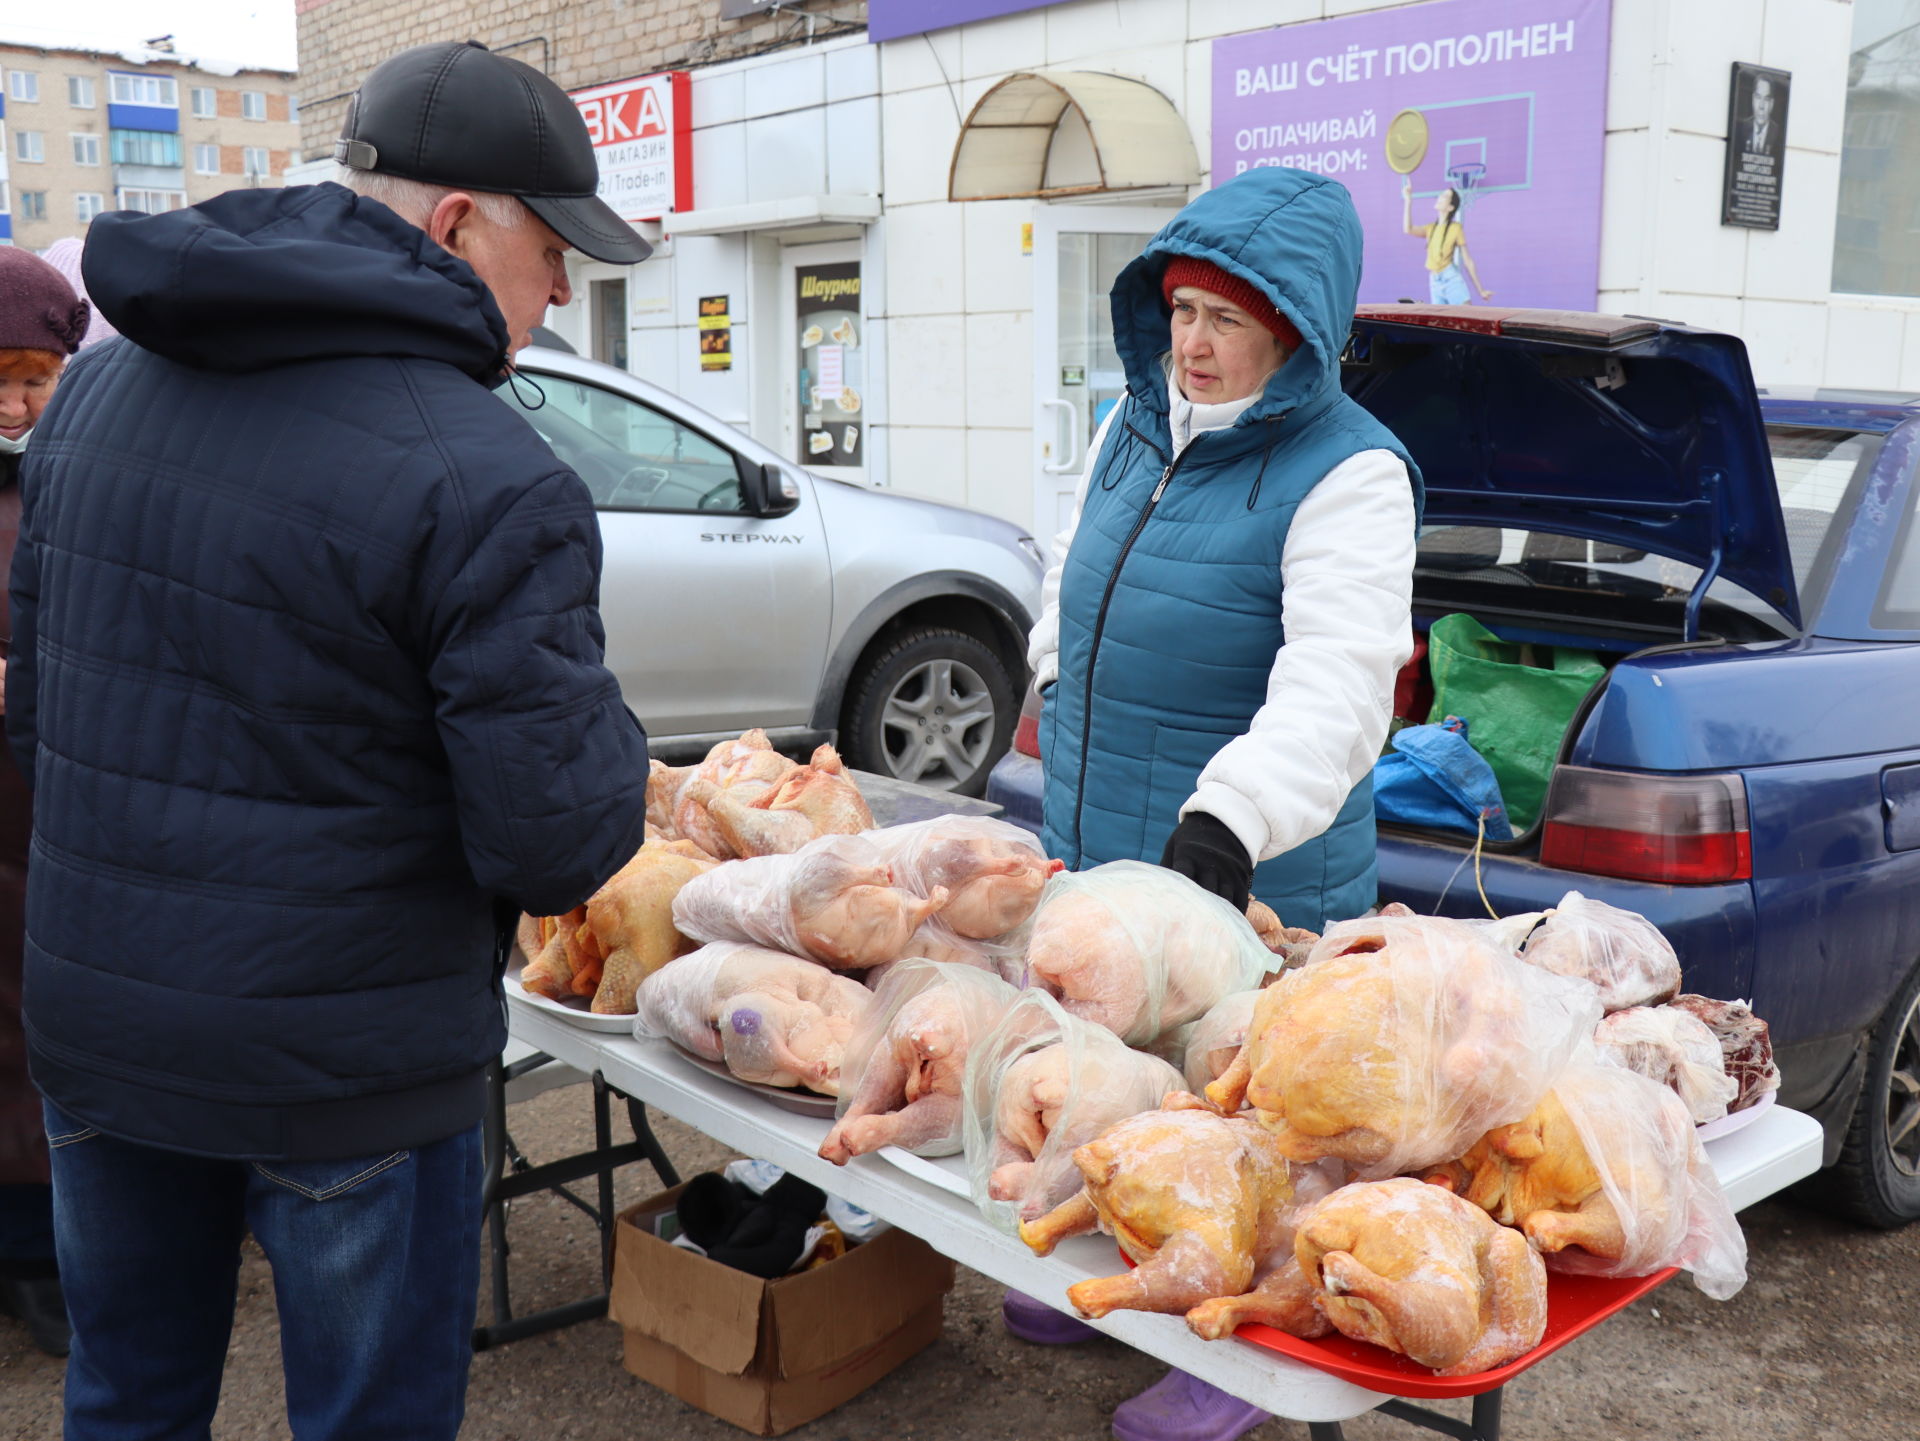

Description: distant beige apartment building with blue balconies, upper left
[0,44,300,251]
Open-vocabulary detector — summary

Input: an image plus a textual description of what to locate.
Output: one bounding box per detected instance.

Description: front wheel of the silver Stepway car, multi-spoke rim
[841,627,1018,796]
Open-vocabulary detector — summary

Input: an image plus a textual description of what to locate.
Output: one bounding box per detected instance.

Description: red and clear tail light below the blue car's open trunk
[1540,766,1753,886]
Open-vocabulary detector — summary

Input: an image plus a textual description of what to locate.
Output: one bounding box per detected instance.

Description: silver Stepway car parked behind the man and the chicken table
[499,345,1043,794]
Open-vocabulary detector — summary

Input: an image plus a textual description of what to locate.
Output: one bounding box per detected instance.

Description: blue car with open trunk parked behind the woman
[987,305,1920,1226]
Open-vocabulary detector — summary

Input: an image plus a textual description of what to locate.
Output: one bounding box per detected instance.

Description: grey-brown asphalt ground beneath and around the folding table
[0,1086,1920,1441]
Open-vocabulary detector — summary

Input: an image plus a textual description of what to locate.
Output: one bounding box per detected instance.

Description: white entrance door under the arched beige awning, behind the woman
[1033,205,1175,537]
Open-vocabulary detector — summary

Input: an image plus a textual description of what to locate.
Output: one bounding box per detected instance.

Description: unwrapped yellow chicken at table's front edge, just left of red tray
[1020,1094,1325,1335]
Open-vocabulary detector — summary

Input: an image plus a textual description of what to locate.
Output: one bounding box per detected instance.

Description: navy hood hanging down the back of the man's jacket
[83,184,507,384]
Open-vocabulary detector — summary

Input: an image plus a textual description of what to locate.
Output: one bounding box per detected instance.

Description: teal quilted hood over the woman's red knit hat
[1112,167,1361,426]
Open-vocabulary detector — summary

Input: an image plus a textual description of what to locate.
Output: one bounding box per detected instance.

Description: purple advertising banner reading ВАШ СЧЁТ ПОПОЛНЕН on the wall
[1213,0,1611,311]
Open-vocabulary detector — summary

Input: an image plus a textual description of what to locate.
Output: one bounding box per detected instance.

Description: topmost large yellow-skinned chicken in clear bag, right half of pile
[1206,915,1599,1180]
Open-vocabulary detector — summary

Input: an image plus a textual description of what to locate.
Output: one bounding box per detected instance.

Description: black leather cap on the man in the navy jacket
[334,40,653,265]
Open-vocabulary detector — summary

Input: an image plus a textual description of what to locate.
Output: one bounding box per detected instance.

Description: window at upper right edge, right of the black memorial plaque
[1834,0,1920,295]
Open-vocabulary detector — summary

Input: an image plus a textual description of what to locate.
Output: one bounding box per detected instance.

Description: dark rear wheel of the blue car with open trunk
[1834,969,1920,1230]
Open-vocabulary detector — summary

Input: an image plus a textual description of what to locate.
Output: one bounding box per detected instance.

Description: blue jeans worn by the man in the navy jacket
[46,1105,482,1441]
